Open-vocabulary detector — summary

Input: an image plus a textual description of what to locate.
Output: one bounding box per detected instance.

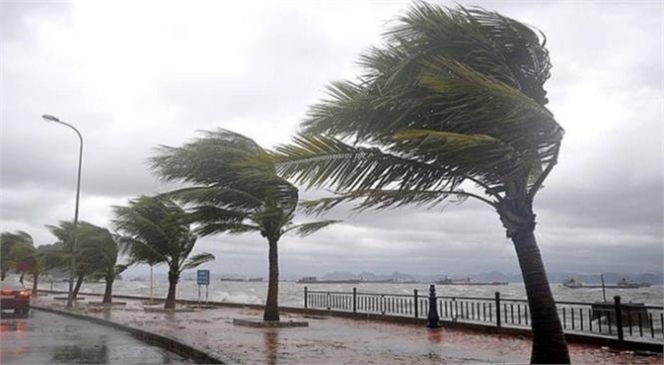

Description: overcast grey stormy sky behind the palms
[0,0,664,277]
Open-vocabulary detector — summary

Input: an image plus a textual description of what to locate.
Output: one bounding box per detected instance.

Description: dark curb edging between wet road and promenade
[30,305,225,364]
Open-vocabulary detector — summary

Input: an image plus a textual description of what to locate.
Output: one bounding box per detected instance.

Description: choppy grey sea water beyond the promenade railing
[40,281,664,307]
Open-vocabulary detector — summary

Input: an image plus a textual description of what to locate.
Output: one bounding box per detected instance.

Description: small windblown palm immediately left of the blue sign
[113,196,214,309]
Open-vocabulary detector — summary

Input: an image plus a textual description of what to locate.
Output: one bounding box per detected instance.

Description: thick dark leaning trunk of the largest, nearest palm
[498,198,570,364]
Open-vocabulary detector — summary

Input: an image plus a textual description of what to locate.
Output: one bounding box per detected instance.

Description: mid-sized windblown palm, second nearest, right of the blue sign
[152,129,336,321]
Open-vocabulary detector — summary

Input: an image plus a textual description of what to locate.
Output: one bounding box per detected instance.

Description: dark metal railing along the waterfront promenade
[304,285,664,343]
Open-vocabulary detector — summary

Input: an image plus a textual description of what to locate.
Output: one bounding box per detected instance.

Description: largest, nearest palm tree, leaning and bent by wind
[275,2,570,363]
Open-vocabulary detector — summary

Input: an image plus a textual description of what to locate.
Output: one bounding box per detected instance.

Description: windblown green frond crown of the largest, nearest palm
[290,2,563,199]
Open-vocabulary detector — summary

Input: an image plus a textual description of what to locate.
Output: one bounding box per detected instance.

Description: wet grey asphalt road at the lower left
[0,310,193,364]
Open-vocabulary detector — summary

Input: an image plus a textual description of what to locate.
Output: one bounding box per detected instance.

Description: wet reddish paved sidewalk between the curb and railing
[33,294,662,364]
